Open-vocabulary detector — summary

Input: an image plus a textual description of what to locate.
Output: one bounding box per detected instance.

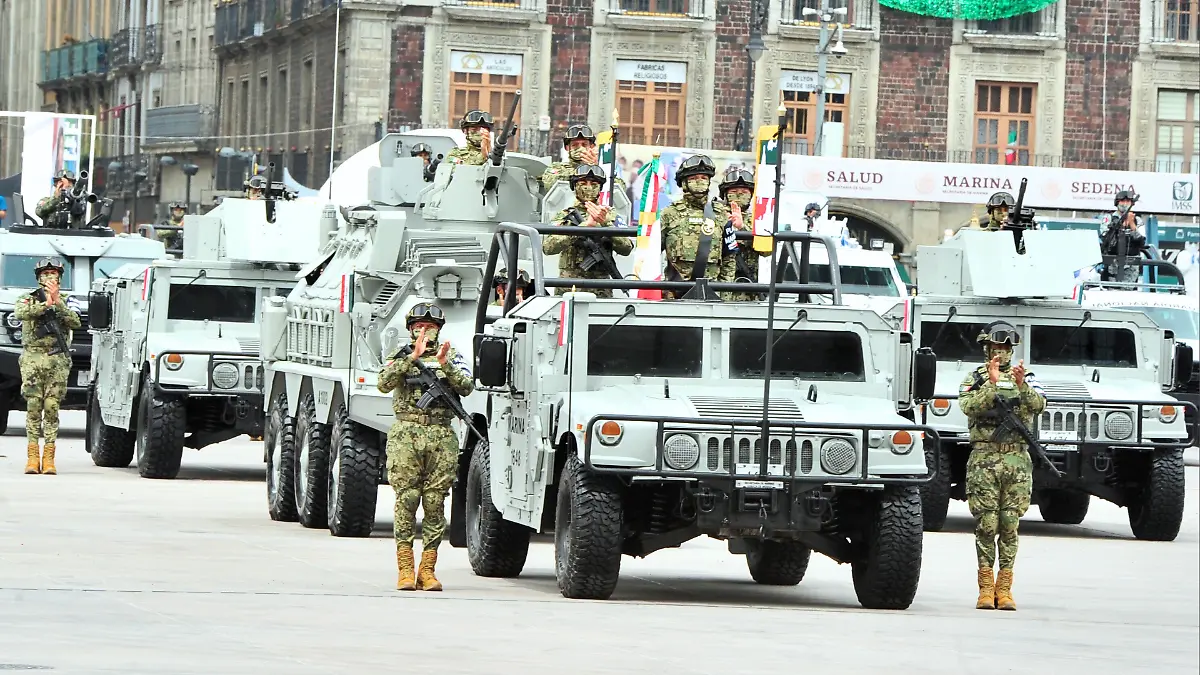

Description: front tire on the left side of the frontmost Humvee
[554,448,623,601]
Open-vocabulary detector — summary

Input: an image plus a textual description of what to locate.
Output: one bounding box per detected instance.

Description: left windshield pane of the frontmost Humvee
[588,324,704,377]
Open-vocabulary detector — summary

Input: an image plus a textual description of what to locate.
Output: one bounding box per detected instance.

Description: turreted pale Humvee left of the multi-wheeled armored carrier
[86,194,337,478]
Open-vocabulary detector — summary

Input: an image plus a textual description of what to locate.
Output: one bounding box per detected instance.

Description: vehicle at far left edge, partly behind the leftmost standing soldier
[0,196,166,434]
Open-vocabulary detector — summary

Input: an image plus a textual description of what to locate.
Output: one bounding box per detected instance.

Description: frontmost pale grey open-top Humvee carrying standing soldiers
[463,223,937,609]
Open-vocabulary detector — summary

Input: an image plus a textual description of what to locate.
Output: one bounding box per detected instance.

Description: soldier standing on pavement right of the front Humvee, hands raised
[959,321,1046,610]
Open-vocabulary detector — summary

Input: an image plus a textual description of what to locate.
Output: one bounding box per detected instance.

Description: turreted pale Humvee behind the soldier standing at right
[886,229,1195,540]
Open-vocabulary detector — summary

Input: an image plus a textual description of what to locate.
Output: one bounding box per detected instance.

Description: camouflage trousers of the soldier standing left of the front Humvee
[388,422,458,551]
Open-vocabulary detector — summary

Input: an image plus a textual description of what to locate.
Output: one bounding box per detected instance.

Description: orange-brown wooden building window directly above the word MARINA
[973,82,1037,166]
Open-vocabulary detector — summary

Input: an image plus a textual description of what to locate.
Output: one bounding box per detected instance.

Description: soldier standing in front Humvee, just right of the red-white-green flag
[659,155,738,297]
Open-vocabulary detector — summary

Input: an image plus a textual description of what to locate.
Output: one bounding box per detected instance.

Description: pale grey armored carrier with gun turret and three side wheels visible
[262,127,629,537]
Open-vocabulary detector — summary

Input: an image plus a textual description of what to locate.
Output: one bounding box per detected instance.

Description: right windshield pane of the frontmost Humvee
[730,328,863,382]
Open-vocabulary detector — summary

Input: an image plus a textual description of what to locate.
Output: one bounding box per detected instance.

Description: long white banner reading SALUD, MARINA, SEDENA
[784,155,1200,215]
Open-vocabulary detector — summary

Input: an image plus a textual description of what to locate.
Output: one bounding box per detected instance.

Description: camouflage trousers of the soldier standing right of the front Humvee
[967,442,1033,569]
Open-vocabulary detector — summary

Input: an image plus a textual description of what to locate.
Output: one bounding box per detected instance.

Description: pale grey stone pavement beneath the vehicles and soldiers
[0,413,1200,675]
